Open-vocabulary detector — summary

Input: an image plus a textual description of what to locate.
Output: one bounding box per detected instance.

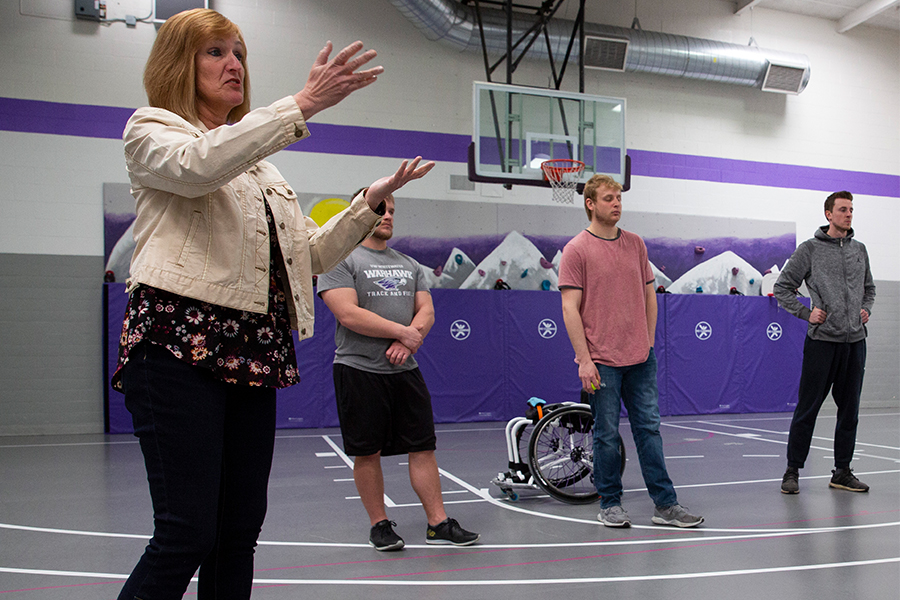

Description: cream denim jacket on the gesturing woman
[123,97,380,339]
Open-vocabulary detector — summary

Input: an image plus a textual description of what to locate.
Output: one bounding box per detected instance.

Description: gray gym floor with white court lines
[0,410,900,600]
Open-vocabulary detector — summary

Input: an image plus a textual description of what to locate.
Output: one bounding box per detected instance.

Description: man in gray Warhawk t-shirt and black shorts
[318,194,479,551]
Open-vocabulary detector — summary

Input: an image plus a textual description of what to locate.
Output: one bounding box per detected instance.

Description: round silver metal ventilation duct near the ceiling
[390,0,810,94]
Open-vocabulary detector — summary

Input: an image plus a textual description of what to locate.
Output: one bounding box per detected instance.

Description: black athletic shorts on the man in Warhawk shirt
[334,363,437,456]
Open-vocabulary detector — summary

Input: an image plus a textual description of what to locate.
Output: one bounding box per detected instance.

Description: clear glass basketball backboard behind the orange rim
[469,81,630,192]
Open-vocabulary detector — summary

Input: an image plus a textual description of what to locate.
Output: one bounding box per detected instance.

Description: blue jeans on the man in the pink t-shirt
[588,348,678,508]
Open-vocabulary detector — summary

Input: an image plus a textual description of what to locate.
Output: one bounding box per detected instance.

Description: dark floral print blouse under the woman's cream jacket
[112,204,300,391]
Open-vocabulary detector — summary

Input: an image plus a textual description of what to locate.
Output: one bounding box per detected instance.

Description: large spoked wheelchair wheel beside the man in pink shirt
[528,404,599,504]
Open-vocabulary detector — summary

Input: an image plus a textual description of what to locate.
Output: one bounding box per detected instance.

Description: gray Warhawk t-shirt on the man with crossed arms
[318,246,428,373]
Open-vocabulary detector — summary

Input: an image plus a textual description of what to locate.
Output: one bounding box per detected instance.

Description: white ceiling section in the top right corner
[735,0,900,32]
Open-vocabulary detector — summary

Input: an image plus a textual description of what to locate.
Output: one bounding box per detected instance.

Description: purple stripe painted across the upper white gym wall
[0,97,900,198]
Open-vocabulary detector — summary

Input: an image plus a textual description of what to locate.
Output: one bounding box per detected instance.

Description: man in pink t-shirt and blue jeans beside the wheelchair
[559,175,703,527]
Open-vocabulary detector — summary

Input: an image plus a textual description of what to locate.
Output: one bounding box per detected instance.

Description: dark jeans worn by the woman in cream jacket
[119,342,275,600]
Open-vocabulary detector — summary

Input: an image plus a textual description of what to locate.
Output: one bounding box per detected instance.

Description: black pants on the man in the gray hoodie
[788,337,866,469]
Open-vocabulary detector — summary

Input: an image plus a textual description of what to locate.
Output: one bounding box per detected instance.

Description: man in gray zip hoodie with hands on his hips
[775,192,875,494]
